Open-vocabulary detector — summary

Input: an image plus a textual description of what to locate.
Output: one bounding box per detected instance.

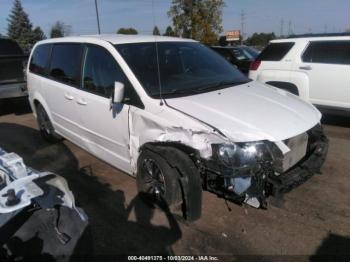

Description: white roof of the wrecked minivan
[41,34,195,44]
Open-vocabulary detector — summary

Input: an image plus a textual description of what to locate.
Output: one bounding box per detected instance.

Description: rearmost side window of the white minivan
[29,44,51,75]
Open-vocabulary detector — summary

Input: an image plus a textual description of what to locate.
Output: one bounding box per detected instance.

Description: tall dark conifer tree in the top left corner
[7,0,36,51]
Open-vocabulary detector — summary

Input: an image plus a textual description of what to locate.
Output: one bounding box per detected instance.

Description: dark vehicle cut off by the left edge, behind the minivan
[0,38,28,99]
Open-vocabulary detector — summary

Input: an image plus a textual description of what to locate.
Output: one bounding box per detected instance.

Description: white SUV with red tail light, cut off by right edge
[249,35,350,113]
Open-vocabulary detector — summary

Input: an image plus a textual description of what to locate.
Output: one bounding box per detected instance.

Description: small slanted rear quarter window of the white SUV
[256,42,294,61]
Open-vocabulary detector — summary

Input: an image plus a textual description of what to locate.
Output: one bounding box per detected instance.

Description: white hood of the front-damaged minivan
[166,82,321,142]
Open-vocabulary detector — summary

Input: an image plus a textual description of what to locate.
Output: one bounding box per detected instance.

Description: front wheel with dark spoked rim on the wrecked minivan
[136,150,182,206]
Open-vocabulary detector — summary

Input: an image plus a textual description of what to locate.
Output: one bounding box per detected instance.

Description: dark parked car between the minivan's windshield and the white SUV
[212,46,259,74]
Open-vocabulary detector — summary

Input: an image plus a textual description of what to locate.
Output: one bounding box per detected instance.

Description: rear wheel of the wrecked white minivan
[36,104,62,143]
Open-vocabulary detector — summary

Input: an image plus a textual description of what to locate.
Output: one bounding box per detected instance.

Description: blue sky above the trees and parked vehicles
[0,0,350,37]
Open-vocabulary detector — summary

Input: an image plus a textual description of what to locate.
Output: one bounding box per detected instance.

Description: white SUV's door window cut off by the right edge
[302,41,350,65]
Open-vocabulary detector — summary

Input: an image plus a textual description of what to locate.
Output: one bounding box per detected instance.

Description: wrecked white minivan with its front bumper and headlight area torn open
[28,35,328,220]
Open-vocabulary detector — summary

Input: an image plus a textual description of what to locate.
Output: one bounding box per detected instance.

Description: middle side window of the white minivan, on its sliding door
[50,44,83,86]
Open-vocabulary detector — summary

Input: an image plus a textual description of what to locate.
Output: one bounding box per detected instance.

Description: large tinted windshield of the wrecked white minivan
[116,42,250,98]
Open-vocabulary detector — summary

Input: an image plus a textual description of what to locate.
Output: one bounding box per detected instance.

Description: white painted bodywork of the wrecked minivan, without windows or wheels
[27,35,321,175]
